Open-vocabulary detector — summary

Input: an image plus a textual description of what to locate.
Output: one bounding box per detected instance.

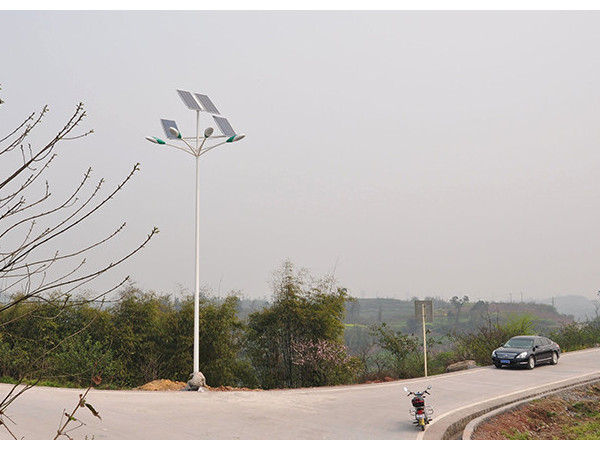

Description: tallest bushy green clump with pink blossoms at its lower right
[246,262,356,388]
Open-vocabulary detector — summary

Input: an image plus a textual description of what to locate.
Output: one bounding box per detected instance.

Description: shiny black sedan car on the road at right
[492,336,560,369]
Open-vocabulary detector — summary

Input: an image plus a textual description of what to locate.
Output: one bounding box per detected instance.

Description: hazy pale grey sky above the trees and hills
[0,10,600,300]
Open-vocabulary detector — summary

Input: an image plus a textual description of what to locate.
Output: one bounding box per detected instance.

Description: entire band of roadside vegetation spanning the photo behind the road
[0,268,600,389]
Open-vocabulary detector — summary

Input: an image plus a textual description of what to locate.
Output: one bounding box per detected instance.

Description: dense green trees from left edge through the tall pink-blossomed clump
[0,263,356,388]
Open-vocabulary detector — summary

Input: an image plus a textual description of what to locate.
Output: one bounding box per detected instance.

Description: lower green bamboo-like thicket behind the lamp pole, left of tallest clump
[0,288,252,387]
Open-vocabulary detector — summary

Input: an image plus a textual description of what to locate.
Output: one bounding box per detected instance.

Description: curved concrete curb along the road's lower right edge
[422,372,600,440]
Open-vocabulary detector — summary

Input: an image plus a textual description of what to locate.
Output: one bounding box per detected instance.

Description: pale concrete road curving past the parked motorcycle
[0,348,600,440]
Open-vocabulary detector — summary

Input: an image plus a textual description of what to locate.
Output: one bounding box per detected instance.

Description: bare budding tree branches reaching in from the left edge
[0,88,158,440]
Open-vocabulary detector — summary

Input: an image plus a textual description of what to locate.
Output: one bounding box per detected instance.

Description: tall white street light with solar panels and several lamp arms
[146,90,245,390]
